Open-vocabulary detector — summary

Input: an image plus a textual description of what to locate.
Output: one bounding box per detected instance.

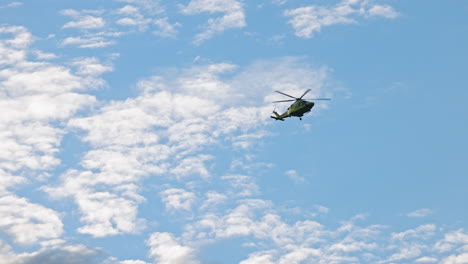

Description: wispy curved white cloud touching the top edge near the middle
[181,0,246,44]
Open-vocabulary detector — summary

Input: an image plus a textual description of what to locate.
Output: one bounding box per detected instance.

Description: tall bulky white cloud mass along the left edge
[0,26,112,244]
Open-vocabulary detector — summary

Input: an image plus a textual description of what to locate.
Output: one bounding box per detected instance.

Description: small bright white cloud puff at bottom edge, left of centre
[146,233,199,264]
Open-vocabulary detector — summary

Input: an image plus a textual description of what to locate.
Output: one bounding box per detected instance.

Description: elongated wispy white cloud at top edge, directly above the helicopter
[284,0,399,38]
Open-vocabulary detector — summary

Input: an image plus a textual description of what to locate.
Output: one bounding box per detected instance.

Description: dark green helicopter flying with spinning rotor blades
[270,89,331,121]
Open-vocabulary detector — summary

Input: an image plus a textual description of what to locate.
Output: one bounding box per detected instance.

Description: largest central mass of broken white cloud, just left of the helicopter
[44,59,330,236]
